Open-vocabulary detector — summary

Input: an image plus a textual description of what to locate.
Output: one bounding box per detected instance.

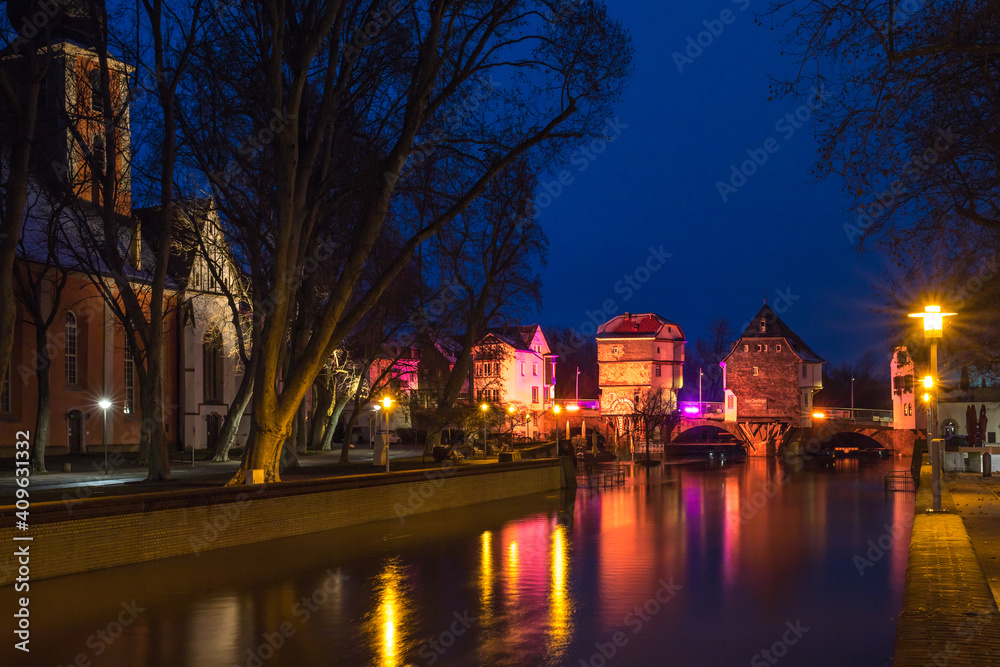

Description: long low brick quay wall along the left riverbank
[0,459,575,586]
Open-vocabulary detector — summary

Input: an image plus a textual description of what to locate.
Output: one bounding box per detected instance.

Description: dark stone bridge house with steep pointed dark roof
[720,304,826,426]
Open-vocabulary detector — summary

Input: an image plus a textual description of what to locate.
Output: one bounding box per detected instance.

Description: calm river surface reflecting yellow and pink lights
[27,460,913,667]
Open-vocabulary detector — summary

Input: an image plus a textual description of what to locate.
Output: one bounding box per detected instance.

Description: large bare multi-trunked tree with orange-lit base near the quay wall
[184,0,631,482]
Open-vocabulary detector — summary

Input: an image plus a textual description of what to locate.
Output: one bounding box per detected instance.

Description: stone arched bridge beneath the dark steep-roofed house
[672,402,915,456]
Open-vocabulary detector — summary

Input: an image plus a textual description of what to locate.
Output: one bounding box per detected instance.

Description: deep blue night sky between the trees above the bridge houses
[536,0,888,368]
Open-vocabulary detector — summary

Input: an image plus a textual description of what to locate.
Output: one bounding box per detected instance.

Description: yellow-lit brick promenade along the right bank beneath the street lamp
[893,465,1000,667]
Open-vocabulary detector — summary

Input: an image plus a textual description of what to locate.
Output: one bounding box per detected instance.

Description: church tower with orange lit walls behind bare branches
[0,0,131,215]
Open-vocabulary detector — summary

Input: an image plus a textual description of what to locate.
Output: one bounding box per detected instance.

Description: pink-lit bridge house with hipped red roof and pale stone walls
[597,313,686,417]
